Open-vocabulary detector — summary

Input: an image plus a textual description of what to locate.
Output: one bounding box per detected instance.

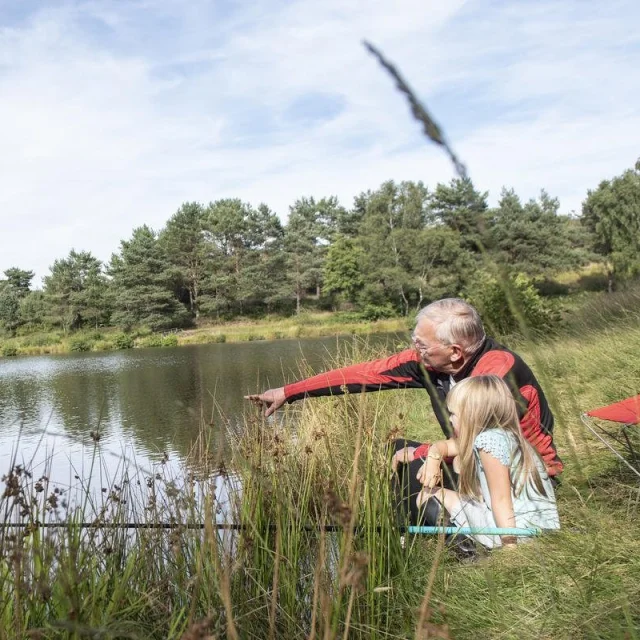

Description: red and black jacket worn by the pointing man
[284,338,563,476]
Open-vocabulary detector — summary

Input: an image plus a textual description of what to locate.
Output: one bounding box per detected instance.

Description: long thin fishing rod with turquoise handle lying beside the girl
[0,522,542,537]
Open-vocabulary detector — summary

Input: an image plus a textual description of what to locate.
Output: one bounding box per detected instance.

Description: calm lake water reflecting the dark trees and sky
[0,336,400,502]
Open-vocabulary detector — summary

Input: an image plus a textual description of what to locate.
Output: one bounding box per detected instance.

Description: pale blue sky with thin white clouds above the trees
[0,0,640,284]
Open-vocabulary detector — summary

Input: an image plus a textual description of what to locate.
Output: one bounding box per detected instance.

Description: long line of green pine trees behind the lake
[0,161,640,335]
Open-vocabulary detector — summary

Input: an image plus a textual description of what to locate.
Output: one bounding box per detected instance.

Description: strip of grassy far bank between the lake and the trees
[0,312,409,357]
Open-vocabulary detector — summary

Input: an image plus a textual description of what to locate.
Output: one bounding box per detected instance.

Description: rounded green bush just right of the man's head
[466,271,559,335]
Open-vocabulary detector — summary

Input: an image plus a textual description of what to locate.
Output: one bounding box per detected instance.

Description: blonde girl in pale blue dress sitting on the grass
[417,376,560,548]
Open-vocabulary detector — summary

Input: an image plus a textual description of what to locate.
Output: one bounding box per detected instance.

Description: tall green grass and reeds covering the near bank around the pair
[0,307,640,640]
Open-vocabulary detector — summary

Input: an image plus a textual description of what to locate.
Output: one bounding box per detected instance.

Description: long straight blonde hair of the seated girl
[447,376,547,497]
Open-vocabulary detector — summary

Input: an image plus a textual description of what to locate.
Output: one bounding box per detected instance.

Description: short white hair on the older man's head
[416,298,485,355]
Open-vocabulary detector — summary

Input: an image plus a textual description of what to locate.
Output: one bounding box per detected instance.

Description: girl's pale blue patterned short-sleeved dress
[451,428,560,548]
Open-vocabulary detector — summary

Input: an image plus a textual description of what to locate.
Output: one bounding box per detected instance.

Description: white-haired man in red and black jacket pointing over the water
[246,298,562,477]
